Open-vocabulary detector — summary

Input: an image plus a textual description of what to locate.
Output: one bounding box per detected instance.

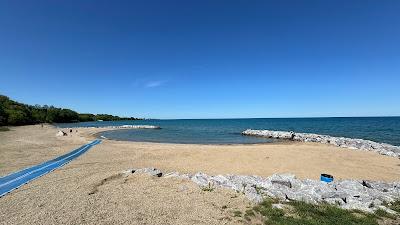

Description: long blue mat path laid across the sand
[0,140,101,197]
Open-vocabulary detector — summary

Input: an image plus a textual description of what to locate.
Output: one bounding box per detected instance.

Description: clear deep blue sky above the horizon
[0,0,400,118]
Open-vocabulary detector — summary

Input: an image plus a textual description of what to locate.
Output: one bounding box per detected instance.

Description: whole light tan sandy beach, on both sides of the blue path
[0,126,400,224]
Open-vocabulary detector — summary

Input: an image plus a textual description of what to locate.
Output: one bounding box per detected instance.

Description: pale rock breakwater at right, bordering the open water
[242,129,400,157]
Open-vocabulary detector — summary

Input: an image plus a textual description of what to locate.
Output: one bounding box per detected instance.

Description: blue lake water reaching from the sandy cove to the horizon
[59,117,400,146]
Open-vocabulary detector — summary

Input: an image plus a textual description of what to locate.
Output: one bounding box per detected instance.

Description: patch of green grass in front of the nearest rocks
[243,199,400,225]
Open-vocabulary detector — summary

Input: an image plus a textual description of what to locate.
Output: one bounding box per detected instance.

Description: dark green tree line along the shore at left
[0,95,139,126]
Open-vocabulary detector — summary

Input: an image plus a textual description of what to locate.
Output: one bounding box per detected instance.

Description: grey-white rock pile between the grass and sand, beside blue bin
[124,168,400,214]
